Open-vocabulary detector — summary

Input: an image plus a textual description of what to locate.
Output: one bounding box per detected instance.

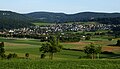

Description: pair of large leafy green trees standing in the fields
[40,36,102,59]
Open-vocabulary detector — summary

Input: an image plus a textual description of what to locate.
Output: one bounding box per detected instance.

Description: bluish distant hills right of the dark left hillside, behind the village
[26,12,120,24]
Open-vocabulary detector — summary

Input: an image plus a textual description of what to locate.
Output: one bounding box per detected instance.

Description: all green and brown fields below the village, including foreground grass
[0,37,120,69]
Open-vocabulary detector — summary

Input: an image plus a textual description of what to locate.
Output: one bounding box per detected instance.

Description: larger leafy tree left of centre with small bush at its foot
[40,36,62,59]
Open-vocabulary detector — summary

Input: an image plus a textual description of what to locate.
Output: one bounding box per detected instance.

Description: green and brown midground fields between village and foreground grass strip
[0,38,120,59]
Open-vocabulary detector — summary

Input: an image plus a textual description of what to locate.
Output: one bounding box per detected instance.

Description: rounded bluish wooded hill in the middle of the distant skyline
[26,12,68,23]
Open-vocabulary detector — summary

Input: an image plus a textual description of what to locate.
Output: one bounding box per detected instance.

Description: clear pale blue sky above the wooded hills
[0,0,120,14]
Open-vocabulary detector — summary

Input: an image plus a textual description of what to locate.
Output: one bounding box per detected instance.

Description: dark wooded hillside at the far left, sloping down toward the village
[0,11,32,29]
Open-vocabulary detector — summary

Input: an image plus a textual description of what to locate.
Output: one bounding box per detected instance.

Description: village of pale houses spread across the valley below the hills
[0,23,119,35]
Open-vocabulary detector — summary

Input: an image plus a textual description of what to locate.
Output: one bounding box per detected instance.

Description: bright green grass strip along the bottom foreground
[0,59,120,69]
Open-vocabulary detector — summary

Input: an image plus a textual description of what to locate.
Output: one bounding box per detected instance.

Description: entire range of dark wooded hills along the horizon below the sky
[0,11,120,29]
